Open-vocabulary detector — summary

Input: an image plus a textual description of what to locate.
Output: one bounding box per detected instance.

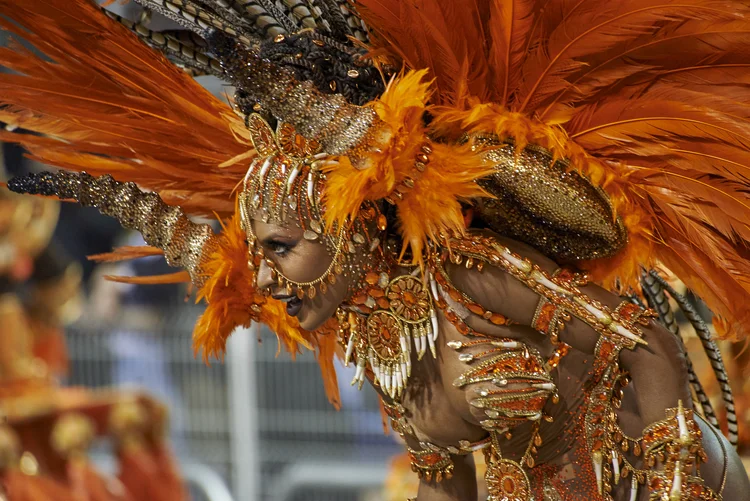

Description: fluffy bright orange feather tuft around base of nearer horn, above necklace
[324,70,491,262]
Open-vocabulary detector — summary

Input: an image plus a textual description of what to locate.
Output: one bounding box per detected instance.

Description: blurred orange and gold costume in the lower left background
[0,185,187,501]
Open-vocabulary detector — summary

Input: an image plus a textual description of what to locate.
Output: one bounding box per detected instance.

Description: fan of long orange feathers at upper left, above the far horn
[0,0,251,219]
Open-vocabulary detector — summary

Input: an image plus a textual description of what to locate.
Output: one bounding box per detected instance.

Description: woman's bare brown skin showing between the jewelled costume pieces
[254,222,750,501]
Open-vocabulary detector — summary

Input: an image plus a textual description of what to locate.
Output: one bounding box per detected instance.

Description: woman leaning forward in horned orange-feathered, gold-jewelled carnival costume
[0,0,750,501]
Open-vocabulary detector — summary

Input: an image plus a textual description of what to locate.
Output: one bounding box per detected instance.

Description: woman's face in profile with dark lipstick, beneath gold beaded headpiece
[253,220,364,331]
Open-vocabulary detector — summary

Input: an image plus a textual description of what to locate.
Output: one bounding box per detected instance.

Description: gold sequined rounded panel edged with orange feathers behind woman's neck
[477,139,627,261]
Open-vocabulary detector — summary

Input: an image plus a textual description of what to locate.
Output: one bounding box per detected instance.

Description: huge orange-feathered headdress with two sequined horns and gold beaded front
[0,0,750,406]
